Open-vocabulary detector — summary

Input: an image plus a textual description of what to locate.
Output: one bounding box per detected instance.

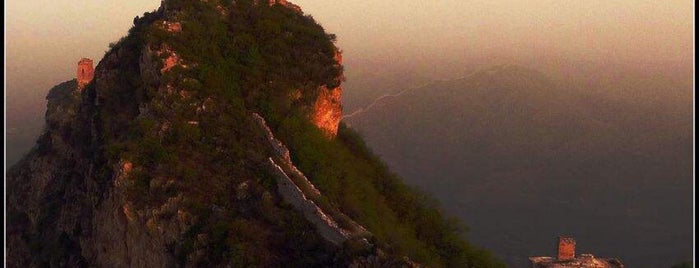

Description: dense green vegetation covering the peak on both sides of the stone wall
[100,0,501,267]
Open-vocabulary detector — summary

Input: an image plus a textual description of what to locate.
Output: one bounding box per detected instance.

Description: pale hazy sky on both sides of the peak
[5,0,694,101]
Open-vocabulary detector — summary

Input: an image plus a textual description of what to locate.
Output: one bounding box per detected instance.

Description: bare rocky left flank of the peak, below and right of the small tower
[7,10,186,267]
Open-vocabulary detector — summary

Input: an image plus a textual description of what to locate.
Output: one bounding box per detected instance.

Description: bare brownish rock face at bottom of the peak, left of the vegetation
[81,160,193,267]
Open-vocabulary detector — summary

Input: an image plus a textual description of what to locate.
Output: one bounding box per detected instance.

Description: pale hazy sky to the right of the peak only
[296,0,693,59]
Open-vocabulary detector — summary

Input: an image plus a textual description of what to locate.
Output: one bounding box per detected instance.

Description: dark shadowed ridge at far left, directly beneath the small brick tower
[6,61,106,267]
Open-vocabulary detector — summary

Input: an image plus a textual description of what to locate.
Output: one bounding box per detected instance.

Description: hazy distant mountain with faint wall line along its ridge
[344,65,693,267]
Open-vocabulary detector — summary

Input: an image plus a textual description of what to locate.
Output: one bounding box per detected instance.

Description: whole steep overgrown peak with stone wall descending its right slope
[7,0,508,267]
